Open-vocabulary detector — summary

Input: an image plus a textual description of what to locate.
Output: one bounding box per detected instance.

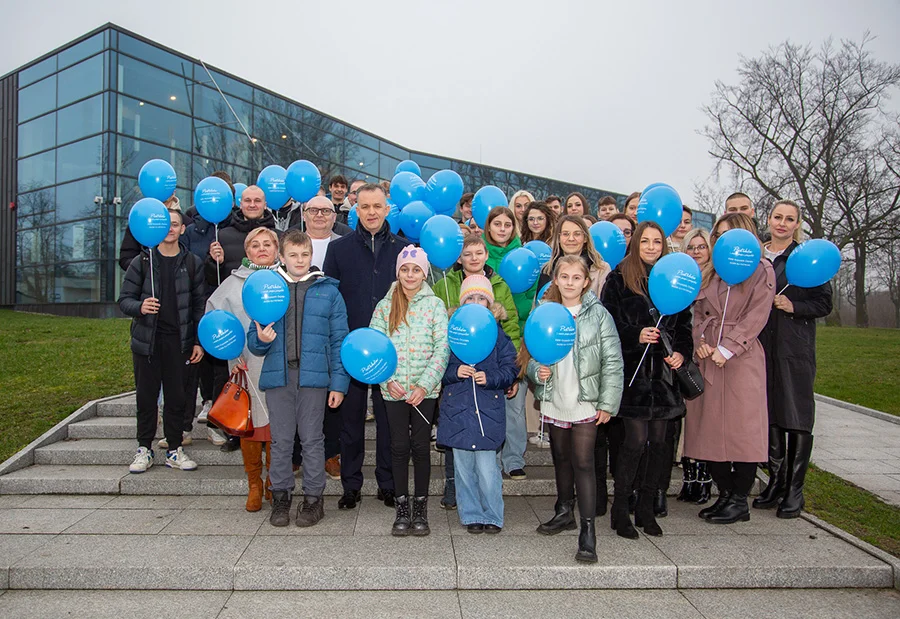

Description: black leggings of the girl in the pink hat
[384,400,437,497]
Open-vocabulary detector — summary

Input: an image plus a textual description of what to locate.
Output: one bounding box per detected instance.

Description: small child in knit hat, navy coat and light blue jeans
[437,275,518,533]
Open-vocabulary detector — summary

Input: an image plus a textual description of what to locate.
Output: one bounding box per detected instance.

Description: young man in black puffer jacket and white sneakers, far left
[119,209,206,473]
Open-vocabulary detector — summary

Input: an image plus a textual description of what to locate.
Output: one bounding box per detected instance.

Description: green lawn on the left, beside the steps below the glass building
[0,310,134,462]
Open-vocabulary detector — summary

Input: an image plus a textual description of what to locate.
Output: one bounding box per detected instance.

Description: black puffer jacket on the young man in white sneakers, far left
[119,245,206,357]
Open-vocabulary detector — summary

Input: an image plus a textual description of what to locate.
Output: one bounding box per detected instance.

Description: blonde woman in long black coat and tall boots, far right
[753,200,832,518]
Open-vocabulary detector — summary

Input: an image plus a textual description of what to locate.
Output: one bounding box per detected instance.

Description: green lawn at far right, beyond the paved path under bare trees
[816,327,900,415]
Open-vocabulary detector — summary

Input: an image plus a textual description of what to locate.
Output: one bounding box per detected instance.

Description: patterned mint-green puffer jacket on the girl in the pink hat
[369,282,450,402]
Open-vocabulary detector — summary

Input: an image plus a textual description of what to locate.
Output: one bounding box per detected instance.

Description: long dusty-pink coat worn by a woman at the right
[684,260,775,462]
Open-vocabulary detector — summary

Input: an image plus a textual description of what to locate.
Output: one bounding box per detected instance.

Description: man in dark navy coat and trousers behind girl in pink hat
[324,184,405,509]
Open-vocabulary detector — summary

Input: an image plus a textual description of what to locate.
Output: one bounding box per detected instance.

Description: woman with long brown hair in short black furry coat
[601,221,694,539]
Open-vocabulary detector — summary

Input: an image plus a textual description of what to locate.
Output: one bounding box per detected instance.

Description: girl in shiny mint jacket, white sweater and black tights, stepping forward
[520,256,623,563]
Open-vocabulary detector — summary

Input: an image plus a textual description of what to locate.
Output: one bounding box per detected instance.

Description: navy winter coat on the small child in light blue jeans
[437,304,518,451]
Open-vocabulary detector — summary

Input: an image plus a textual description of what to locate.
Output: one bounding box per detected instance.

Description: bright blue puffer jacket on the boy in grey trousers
[247,277,350,393]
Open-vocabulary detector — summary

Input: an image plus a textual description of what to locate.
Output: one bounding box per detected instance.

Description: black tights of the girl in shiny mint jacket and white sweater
[550,422,597,518]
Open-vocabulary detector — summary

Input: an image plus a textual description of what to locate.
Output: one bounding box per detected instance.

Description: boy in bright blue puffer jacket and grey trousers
[247,230,350,527]
